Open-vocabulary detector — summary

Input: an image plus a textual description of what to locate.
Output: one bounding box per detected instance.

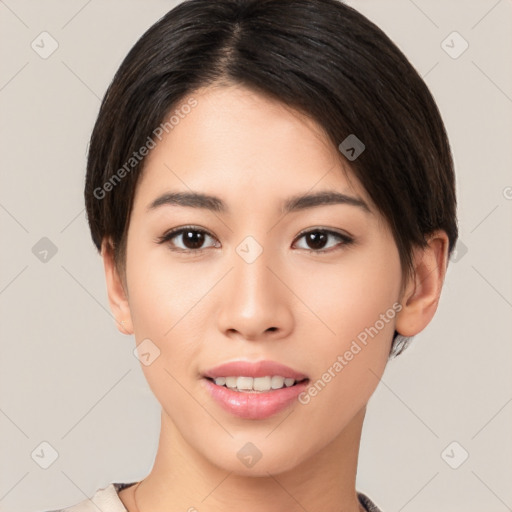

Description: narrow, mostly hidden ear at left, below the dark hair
[101,238,133,334]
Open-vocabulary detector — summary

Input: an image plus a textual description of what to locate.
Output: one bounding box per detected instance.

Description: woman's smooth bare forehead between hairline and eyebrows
[135,86,371,208]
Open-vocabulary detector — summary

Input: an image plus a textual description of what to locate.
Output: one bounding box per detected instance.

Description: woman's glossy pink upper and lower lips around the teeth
[202,361,309,420]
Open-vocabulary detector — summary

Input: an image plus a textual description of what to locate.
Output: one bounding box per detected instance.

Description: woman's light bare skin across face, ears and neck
[102,86,448,512]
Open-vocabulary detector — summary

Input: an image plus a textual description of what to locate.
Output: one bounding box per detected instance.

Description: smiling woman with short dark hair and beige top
[42,0,457,512]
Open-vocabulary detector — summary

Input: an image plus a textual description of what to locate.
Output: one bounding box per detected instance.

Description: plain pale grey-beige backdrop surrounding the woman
[0,0,512,512]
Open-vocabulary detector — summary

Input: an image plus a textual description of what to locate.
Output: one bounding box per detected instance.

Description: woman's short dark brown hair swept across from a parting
[85,0,458,354]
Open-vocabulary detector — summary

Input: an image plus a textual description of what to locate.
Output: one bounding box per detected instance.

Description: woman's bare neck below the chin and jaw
[133,409,365,512]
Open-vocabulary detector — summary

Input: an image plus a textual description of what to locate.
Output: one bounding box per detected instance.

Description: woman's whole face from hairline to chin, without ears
[115,83,401,475]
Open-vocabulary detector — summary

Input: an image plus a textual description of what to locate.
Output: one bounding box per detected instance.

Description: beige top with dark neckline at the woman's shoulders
[47,482,381,512]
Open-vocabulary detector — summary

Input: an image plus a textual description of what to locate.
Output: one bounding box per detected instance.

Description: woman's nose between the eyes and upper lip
[218,246,294,341]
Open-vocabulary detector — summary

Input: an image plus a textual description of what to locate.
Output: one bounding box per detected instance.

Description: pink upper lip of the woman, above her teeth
[203,361,308,381]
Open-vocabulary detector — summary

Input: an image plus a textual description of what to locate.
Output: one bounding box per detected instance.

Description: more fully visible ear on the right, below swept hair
[395,230,449,336]
